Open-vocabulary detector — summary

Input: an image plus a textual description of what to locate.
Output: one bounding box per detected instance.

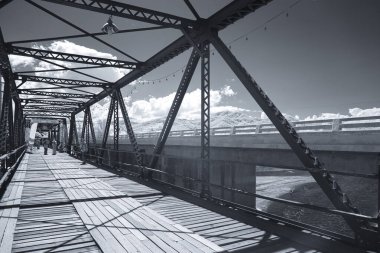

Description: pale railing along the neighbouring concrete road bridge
[119,116,380,139]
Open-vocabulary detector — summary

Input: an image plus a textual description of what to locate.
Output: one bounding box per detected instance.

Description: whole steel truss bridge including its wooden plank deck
[0,0,380,252]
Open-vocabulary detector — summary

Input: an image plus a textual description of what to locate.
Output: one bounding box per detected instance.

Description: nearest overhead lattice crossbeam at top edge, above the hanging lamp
[45,0,195,28]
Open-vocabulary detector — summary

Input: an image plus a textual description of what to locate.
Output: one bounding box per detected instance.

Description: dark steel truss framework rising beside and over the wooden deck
[0,0,378,249]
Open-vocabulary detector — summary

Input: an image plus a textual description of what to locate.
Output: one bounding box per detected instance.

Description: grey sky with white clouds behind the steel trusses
[0,0,380,122]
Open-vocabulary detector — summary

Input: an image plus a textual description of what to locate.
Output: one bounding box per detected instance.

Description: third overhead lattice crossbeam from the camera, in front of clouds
[15,75,108,87]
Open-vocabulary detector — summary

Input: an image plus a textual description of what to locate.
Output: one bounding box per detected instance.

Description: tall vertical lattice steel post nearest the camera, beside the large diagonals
[201,41,211,197]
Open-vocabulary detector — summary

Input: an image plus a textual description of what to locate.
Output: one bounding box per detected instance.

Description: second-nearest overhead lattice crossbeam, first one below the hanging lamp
[7,45,138,69]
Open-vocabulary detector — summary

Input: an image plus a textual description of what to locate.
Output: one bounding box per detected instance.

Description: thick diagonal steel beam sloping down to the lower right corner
[211,34,364,236]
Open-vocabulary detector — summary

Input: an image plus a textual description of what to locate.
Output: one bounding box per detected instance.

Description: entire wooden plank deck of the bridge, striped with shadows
[0,150,364,253]
